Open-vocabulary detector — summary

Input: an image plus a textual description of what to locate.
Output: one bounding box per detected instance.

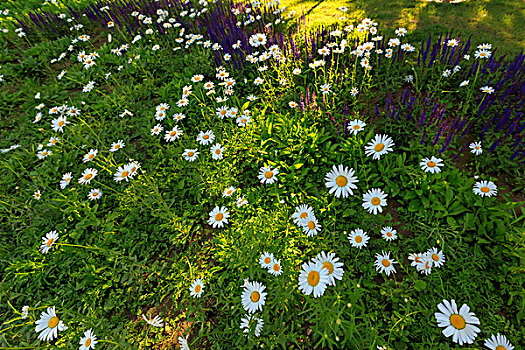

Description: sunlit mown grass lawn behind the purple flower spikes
[282,0,525,55]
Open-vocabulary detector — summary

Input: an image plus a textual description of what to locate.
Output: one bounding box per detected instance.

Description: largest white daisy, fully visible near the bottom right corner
[435,299,480,345]
